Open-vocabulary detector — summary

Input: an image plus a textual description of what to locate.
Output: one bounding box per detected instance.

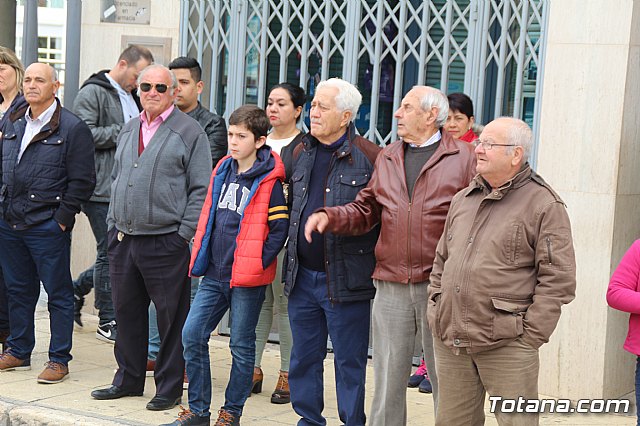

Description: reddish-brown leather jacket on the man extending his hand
[320,129,476,284]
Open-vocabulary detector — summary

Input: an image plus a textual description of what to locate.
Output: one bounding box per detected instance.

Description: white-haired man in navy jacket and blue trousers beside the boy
[284,78,380,426]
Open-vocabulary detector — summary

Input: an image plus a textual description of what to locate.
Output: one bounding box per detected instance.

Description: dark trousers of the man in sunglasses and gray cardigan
[107,228,190,398]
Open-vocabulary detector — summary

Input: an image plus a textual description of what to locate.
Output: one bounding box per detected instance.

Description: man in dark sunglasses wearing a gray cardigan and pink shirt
[91,65,211,410]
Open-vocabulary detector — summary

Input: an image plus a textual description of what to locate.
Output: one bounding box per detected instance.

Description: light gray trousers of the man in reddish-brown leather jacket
[369,280,438,426]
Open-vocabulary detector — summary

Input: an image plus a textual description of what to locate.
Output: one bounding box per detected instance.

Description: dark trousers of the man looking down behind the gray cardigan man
[73,201,116,325]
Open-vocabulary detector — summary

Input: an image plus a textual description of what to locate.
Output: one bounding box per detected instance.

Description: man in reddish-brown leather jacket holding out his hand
[305,86,475,426]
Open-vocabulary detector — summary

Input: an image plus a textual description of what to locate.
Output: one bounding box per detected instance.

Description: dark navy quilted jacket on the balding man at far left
[0,99,96,230]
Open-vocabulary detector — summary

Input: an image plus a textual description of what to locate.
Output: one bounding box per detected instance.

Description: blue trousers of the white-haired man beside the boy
[289,266,370,426]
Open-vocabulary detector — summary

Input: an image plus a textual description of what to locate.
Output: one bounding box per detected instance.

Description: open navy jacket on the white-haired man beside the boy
[284,124,380,303]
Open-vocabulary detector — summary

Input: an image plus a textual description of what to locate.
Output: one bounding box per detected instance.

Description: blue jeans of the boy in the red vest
[182,277,265,416]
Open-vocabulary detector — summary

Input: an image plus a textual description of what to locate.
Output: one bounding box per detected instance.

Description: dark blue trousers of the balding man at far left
[0,219,73,365]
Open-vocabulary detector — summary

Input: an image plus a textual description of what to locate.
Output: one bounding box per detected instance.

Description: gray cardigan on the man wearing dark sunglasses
[107,108,211,240]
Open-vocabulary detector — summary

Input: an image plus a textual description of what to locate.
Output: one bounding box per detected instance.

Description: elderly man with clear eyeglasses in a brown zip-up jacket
[427,117,576,426]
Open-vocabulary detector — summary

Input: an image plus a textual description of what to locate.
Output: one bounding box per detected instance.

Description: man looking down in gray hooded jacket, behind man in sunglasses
[73,45,153,343]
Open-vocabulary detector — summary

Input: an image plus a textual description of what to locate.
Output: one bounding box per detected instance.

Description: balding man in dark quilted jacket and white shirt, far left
[0,63,96,383]
